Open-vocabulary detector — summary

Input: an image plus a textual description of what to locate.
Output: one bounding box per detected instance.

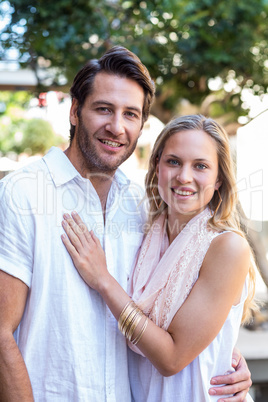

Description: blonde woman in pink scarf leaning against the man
[60,115,254,402]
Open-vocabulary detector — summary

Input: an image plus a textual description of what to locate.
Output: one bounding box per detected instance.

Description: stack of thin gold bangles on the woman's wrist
[118,301,149,345]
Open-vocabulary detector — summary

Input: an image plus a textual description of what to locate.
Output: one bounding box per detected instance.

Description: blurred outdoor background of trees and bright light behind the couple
[0,0,268,402]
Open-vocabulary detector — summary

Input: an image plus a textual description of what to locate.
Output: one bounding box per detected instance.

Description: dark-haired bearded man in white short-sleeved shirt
[0,47,250,402]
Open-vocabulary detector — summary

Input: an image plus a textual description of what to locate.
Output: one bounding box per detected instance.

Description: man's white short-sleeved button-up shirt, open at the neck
[0,148,144,402]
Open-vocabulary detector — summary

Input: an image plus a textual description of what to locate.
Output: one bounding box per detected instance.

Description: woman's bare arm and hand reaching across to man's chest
[62,214,249,386]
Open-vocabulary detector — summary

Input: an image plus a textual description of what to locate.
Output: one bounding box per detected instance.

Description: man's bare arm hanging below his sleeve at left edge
[0,270,34,402]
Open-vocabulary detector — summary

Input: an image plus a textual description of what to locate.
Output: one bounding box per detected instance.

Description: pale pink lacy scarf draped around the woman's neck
[129,208,218,353]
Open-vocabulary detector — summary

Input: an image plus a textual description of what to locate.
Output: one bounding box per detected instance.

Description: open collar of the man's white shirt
[43,147,130,188]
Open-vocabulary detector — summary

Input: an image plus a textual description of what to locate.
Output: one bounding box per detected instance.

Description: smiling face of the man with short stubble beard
[70,73,144,174]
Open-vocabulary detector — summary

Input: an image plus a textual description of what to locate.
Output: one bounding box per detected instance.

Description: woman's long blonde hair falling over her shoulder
[145,115,256,322]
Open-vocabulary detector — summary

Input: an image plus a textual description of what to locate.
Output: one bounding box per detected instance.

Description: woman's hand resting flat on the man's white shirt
[61,212,110,291]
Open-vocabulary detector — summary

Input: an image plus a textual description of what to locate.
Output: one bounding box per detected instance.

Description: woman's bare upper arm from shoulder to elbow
[157,233,250,371]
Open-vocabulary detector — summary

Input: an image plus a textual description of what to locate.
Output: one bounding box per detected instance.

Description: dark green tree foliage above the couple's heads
[1,0,268,118]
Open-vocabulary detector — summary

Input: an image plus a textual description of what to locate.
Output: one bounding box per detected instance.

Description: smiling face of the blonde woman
[157,130,221,223]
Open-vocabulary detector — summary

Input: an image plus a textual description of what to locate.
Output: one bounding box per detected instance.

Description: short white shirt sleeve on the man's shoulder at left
[0,180,33,287]
